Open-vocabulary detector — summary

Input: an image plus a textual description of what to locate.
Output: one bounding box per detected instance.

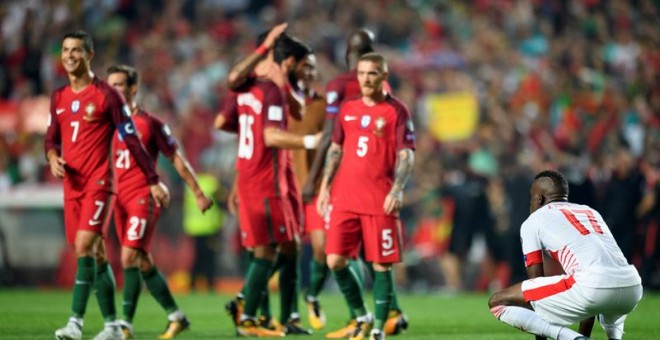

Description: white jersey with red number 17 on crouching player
[520,202,642,288]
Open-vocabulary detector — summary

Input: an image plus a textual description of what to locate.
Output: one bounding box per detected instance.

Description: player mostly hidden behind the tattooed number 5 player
[302,29,408,339]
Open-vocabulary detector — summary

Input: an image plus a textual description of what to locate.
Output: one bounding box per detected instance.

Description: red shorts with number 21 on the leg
[115,188,160,252]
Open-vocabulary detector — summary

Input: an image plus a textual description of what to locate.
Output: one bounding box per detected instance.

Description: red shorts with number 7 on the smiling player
[64,191,116,244]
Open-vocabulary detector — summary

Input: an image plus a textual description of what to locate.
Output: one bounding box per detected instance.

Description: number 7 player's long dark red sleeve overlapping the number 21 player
[105,88,158,185]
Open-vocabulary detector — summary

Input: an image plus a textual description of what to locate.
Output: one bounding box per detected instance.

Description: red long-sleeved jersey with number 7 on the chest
[45,78,158,199]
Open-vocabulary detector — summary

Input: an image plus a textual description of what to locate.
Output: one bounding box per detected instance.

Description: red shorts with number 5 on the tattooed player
[325,210,403,263]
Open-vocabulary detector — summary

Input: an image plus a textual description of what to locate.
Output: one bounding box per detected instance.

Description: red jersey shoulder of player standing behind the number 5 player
[325,69,392,119]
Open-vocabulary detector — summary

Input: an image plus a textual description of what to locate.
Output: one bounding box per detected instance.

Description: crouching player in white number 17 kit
[488,170,642,340]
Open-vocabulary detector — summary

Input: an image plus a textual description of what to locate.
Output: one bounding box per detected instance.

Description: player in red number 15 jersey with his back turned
[215,26,320,337]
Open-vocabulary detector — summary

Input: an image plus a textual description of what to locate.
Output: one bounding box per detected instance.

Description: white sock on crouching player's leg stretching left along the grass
[490,306,582,340]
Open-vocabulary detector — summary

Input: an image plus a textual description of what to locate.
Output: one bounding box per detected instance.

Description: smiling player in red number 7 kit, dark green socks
[44,31,169,340]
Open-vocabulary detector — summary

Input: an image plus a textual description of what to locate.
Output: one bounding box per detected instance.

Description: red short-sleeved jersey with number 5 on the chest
[330,95,415,215]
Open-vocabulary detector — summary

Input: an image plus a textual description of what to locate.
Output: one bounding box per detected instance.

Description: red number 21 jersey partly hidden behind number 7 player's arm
[112,110,177,195]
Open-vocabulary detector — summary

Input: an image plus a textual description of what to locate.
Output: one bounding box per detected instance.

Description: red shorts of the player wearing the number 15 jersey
[238,197,295,248]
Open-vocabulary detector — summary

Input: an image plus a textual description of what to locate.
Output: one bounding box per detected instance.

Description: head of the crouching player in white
[529,170,568,213]
